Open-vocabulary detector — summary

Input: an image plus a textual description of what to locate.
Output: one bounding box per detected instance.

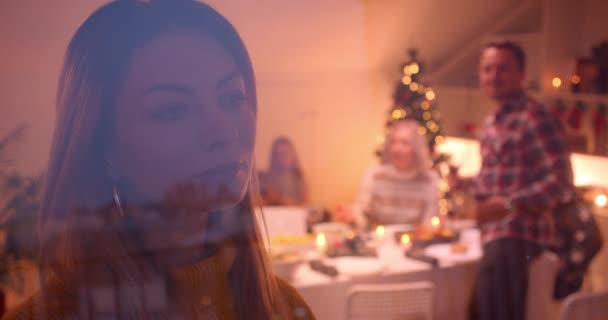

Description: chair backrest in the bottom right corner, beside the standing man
[561,291,608,320]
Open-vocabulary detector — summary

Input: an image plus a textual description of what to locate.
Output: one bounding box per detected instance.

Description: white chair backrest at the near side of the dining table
[346,281,433,320]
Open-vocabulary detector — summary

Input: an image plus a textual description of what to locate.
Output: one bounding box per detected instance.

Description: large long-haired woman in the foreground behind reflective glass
[5,0,314,319]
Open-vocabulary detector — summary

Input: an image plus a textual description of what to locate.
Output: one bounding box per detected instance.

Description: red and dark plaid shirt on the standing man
[474,94,575,245]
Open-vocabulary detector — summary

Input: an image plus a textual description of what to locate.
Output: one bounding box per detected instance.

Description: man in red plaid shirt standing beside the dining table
[453,42,575,320]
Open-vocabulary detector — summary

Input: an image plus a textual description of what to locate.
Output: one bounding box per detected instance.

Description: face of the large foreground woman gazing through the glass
[108,32,255,250]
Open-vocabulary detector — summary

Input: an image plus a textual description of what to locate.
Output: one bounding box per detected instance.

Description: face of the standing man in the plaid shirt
[479,48,525,100]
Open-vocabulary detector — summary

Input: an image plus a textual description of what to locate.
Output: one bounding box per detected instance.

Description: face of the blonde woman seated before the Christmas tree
[387,126,415,170]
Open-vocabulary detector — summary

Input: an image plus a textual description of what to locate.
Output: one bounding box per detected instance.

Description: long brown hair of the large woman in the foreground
[40,0,279,319]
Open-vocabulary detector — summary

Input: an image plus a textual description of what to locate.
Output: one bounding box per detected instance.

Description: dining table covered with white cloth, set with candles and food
[291,242,481,320]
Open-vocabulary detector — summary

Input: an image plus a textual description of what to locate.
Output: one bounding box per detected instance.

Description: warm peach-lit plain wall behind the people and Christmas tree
[0,0,608,206]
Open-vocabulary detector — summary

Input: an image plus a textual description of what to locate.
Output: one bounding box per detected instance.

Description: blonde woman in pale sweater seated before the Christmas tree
[348,120,439,229]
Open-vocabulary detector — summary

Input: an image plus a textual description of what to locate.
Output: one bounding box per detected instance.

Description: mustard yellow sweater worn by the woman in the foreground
[3,246,315,320]
